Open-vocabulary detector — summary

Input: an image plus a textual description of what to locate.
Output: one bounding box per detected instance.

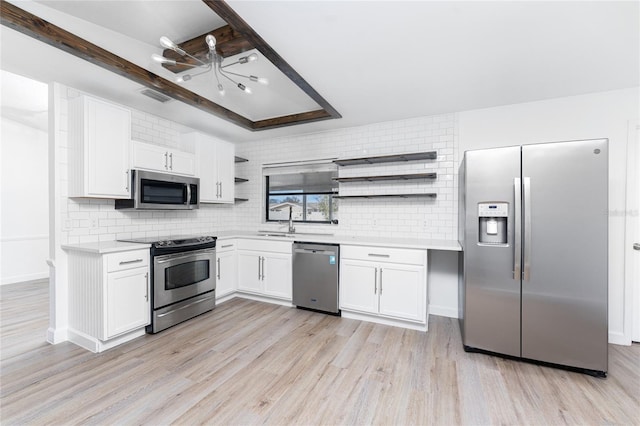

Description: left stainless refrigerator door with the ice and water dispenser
[461,146,520,356]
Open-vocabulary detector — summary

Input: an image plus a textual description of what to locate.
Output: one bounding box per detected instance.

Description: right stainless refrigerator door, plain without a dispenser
[522,139,608,371]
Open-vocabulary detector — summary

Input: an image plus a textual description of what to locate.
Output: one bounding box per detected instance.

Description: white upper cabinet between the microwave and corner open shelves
[182,132,235,203]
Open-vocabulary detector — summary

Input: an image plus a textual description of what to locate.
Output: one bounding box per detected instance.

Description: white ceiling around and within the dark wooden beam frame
[0,0,640,142]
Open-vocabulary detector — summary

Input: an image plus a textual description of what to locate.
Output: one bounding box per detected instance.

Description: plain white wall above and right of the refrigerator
[459,88,640,344]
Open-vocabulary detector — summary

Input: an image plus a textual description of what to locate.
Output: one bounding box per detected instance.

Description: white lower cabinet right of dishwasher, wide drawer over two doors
[340,245,428,331]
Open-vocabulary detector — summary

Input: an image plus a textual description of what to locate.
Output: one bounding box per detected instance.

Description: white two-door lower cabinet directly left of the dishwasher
[238,239,292,301]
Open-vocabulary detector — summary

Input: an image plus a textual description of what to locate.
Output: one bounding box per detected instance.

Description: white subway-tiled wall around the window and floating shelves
[235,114,457,240]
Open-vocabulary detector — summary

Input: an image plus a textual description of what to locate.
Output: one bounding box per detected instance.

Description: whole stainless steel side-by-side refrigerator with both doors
[459,139,608,376]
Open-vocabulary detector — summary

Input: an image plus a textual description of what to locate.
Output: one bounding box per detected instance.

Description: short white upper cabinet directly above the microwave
[132,141,196,176]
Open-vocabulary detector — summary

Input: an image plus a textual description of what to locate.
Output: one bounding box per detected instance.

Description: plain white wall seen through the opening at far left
[0,116,49,284]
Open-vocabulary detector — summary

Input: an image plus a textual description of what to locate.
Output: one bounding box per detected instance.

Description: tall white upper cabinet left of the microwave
[69,96,131,199]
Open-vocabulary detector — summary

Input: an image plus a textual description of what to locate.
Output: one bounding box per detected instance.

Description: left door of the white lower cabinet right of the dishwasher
[340,259,378,313]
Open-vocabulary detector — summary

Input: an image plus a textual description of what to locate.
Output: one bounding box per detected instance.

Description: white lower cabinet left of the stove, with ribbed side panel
[69,249,151,352]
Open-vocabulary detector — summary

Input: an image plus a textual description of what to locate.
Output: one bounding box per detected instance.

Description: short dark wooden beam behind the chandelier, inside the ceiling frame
[162,25,253,73]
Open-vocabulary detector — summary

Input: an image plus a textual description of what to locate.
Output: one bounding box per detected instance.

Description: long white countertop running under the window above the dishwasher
[217,231,462,251]
